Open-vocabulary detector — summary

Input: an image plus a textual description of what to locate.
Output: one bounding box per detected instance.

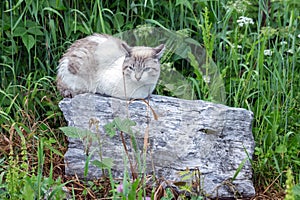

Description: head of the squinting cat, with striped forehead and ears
[121,43,165,84]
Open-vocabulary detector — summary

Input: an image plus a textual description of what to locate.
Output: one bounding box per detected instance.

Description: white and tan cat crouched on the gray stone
[56,34,165,99]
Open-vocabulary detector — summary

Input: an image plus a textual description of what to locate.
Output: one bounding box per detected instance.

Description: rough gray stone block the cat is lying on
[59,94,255,199]
